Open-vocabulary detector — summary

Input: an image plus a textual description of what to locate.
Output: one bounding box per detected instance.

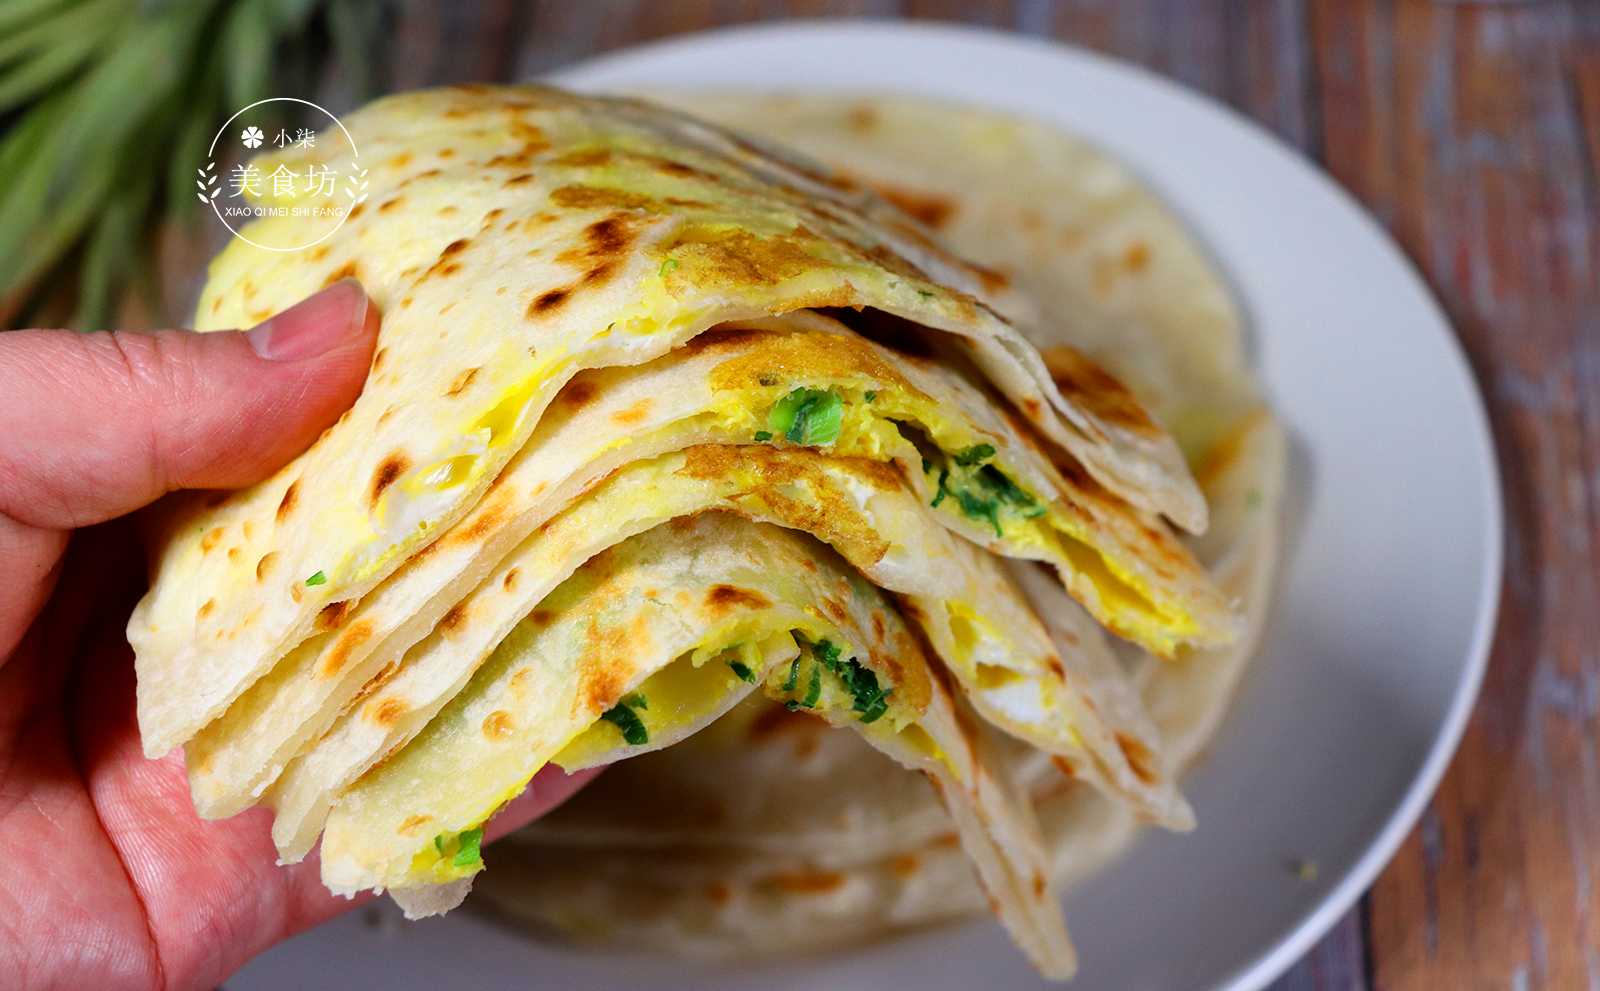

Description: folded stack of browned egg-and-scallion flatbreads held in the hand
[128,86,1277,977]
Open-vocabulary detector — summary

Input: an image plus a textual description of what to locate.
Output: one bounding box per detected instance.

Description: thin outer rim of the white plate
[539,18,1506,991]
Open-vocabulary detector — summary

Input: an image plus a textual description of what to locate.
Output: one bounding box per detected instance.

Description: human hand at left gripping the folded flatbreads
[0,282,587,988]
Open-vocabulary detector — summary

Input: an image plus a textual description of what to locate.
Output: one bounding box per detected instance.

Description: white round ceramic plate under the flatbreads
[229,22,1501,991]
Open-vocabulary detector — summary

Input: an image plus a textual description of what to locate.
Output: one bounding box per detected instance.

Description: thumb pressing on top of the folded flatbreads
[0,280,378,530]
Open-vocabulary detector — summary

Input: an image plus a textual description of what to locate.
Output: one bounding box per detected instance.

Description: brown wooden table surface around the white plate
[377,0,1600,991]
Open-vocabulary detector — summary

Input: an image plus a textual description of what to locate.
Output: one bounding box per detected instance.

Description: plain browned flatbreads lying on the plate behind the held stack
[478,93,1286,956]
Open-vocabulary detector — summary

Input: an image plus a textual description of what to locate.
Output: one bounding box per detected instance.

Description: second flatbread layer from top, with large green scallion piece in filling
[186,312,1234,818]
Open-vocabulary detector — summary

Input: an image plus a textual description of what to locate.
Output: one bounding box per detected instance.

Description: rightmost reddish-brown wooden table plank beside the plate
[1314,2,1600,988]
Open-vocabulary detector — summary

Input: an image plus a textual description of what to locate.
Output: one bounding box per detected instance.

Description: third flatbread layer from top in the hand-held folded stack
[267,445,1192,860]
